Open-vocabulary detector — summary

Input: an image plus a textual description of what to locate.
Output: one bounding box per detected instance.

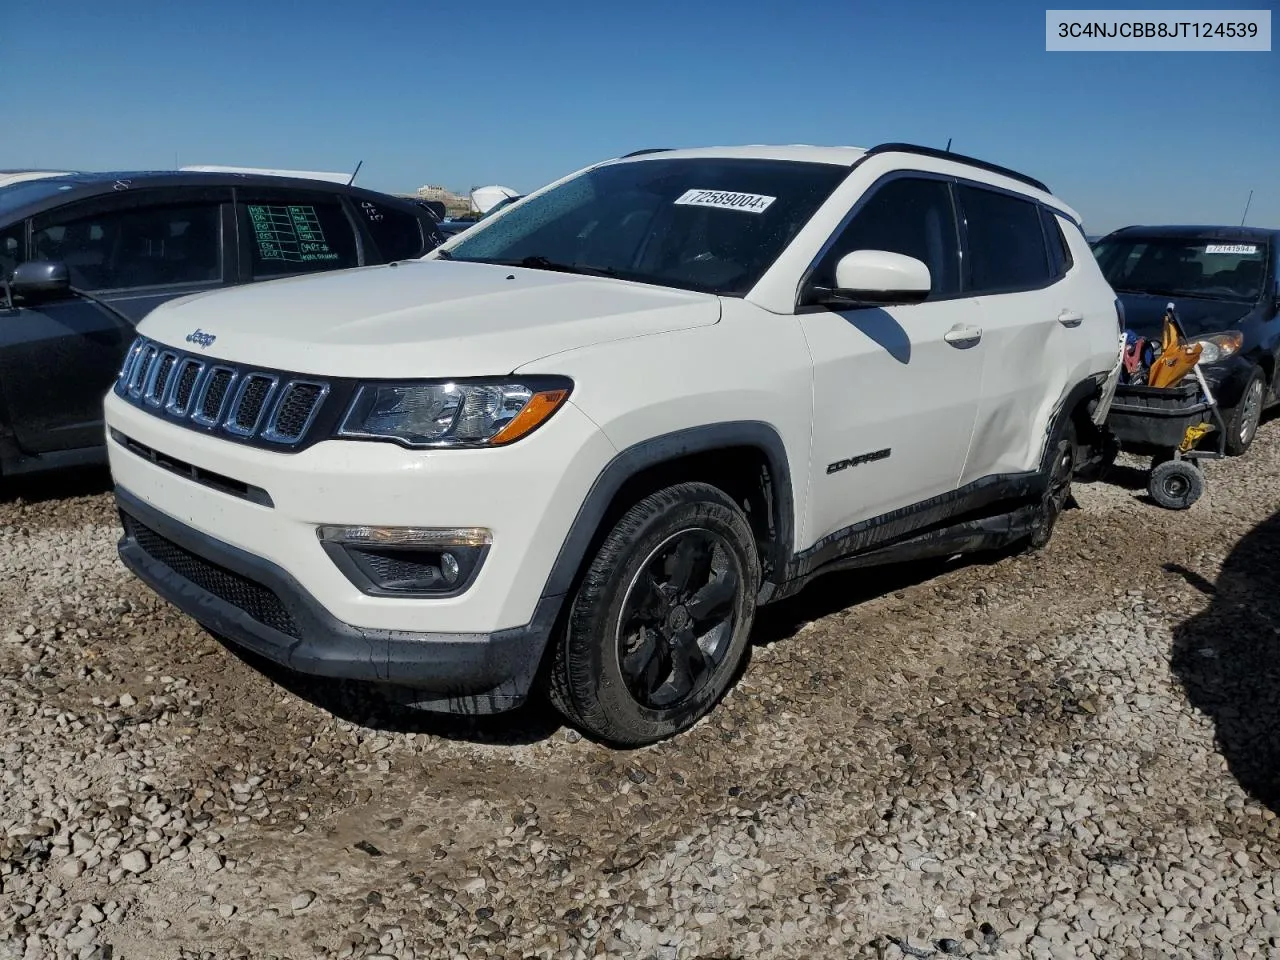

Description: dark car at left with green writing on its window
[0,172,444,475]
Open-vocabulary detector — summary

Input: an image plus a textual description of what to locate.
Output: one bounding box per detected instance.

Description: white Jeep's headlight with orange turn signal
[338,376,572,447]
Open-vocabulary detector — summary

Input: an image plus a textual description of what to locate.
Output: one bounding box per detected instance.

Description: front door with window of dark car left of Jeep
[0,188,230,453]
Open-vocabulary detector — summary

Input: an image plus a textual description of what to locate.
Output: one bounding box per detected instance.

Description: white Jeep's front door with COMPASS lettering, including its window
[800,174,983,544]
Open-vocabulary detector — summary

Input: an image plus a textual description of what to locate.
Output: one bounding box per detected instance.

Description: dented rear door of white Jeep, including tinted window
[956,182,1080,484]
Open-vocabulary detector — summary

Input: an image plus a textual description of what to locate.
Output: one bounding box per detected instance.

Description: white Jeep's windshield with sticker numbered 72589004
[448,159,849,297]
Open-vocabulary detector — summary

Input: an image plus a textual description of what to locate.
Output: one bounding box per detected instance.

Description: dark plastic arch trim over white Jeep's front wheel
[543,420,795,609]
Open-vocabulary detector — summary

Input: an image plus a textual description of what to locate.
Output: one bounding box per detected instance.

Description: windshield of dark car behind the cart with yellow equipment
[1093,237,1270,301]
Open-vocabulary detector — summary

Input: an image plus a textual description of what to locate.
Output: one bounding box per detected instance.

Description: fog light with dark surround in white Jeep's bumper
[316,526,493,596]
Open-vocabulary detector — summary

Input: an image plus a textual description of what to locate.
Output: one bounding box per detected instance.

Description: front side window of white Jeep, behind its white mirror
[813,177,960,300]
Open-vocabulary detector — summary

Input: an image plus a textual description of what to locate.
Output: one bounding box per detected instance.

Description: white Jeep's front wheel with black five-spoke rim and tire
[548,483,760,746]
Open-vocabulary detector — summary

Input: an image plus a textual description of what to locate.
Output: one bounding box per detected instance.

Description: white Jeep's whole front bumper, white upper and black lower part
[105,393,616,713]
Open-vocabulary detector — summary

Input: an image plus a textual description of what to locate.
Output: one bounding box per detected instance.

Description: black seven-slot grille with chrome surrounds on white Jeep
[115,337,330,447]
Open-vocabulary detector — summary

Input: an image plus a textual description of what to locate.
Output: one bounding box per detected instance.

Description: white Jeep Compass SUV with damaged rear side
[106,143,1120,744]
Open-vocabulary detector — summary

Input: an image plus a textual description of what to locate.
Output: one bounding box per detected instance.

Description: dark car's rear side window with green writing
[236,186,363,282]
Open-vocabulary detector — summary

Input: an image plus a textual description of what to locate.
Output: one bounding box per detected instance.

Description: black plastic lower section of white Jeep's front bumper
[115,488,558,713]
